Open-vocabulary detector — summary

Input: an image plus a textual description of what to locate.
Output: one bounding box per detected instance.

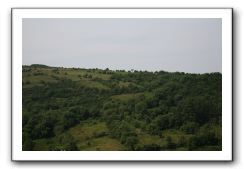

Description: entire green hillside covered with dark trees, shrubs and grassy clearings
[22,65,222,151]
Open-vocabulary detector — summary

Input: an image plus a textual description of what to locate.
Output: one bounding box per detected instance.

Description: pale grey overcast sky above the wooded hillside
[23,18,222,73]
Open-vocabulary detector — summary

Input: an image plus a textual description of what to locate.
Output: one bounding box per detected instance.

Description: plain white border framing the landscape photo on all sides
[12,8,232,161]
